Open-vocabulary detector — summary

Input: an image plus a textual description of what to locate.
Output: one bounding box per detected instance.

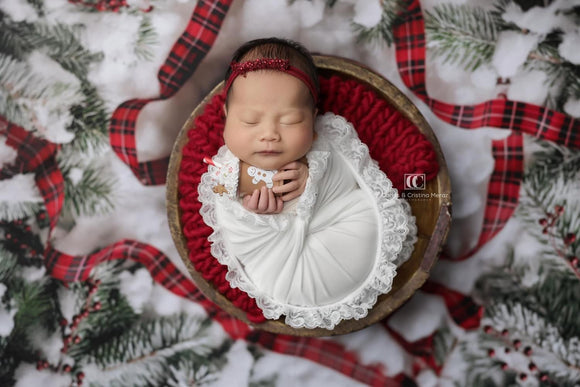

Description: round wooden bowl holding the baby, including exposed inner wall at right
[166,55,451,336]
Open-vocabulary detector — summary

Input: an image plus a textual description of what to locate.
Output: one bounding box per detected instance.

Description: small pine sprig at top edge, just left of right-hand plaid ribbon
[352,0,406,46]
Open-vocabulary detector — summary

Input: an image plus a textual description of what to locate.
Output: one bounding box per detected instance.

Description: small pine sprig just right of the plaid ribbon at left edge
[61,165,114,216]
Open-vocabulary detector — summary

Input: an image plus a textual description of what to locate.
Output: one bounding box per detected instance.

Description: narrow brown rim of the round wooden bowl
[166,54,451,337]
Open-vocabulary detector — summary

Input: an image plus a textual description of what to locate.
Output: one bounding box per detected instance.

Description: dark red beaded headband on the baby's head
[224,58,318,105]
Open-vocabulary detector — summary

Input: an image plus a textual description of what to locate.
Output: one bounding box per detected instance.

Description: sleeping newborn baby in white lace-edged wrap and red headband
[198,38,416,329]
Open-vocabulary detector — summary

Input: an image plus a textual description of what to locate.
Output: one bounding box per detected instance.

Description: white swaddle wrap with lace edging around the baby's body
[198,113,416,329]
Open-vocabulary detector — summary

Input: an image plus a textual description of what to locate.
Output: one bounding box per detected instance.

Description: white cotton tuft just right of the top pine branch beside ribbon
[492,31,539,78]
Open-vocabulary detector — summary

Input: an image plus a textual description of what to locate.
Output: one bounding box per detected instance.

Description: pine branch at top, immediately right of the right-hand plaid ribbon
[425,4,505,71]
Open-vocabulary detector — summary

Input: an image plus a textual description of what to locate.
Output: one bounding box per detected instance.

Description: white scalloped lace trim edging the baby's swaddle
[198,113,417,330]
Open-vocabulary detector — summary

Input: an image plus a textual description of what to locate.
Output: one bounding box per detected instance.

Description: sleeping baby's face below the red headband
[224,70,316,170]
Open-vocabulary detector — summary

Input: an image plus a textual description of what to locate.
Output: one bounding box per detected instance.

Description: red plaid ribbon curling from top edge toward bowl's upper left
[109,0,232,185]
